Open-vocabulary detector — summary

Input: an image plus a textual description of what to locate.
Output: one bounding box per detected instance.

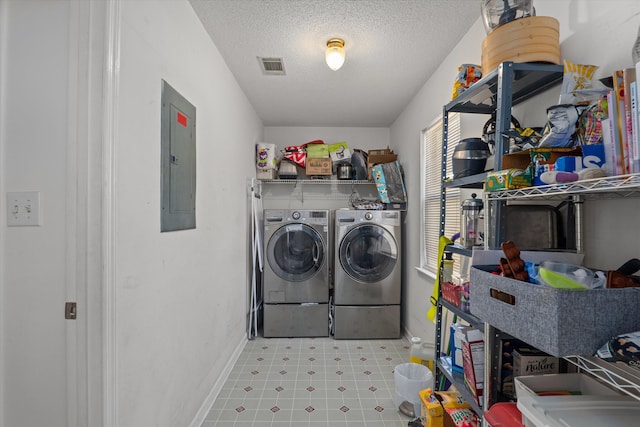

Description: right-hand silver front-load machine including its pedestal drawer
[333,210,402,339]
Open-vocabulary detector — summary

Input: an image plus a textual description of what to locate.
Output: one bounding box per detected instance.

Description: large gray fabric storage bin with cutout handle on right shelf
[471,251,640,357]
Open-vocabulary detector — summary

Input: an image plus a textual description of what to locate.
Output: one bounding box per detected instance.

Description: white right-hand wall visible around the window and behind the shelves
[391,0,640,341]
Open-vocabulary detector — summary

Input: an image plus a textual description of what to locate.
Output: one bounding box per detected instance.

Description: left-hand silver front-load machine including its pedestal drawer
[262,209,331,337]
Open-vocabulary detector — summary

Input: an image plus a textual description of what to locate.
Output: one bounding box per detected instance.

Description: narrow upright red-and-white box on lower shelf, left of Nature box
[462,328,484,406]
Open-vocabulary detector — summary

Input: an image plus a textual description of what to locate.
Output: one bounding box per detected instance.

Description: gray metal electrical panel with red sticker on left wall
[160,80,196,231]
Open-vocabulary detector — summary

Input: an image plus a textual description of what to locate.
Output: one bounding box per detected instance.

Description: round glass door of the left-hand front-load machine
[267,224,325,282]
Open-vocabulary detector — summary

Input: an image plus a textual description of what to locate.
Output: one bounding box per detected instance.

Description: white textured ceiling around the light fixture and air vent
[189,0,480,127]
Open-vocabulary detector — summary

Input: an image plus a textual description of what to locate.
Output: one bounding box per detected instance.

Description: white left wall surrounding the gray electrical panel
[114,0,262,427]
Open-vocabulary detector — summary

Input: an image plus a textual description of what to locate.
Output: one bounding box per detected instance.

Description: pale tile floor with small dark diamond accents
[202,337,418,427]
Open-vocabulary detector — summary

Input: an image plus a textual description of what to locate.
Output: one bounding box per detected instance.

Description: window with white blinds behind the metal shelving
[421,114,461,275]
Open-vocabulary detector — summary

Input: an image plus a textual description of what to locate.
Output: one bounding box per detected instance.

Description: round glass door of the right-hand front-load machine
[339,224,398,283]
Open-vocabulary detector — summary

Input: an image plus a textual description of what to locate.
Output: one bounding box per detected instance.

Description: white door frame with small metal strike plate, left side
[66,0,121,427]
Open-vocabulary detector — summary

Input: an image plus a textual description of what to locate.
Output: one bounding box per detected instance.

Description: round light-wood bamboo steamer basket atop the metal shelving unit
[482,16,561,75]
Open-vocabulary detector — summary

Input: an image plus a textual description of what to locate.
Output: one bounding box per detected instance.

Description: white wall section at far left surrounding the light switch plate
[0,1,70,427]
